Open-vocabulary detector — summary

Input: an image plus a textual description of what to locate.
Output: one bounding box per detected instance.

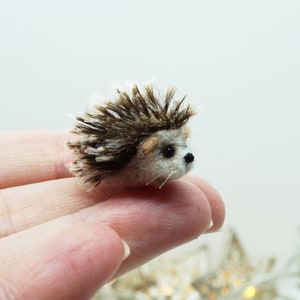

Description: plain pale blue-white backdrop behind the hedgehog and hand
[0,0,300,292]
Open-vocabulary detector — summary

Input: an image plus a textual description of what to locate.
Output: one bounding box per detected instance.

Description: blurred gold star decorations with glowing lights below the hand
[94,229,300,300]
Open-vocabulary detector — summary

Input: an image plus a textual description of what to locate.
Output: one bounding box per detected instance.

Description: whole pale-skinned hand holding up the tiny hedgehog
[0,131,225,300]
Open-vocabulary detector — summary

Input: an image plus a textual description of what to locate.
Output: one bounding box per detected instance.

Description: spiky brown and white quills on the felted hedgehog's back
[68,85,194,185]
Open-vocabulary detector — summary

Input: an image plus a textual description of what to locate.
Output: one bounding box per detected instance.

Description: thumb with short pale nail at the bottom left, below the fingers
[0,224,129,300]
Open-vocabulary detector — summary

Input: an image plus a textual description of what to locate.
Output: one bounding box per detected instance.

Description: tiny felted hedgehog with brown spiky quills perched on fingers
[68,85,195,188]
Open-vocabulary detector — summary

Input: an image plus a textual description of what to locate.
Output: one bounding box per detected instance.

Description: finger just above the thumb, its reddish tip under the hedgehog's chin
[0,181,211,272]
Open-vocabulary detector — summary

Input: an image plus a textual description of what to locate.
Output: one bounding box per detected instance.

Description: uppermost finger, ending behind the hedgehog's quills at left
[0,131,72,189]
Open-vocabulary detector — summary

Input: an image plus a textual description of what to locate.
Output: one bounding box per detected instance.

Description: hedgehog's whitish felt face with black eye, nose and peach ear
[136,127,194,187]
